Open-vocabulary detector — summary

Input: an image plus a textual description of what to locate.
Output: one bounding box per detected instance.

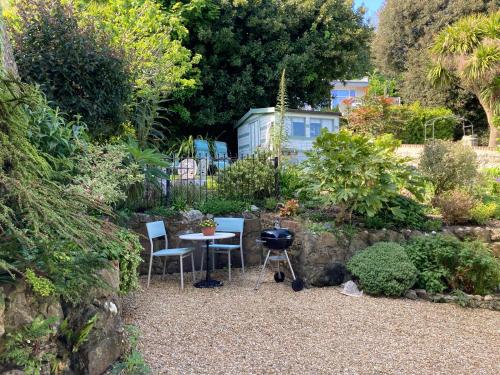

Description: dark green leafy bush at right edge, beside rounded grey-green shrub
[405,235,500,294]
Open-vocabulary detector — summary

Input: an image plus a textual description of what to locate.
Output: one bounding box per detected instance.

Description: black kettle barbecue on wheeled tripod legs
[255,225,304,292]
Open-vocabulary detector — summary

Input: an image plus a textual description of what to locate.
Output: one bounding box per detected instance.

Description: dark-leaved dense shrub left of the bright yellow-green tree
[10,0,131,138]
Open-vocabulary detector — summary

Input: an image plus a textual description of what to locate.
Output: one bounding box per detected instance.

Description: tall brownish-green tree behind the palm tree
[372,0,498,142]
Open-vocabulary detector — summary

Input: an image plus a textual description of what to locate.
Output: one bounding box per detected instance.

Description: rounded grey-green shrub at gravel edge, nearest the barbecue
[347,242,417,296]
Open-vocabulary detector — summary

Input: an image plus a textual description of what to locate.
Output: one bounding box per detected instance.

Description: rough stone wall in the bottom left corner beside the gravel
[0,263,126,375]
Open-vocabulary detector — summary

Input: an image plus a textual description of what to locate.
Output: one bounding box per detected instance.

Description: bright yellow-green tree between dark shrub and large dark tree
[78,0,201,147]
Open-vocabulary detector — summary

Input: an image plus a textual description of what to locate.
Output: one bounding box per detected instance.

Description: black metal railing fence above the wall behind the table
[139,154,279,209]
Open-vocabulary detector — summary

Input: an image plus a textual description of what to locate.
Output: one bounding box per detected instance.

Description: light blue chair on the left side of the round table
[146,221,196,289]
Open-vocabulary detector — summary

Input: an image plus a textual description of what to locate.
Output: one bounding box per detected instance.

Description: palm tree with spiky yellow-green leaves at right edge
[428,11,500,147]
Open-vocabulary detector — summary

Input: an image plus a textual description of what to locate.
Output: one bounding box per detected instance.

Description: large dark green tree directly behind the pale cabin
[164,0,371,139]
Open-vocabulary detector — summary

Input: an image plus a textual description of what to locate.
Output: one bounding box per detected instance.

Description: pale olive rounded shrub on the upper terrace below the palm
[419,140,477,195]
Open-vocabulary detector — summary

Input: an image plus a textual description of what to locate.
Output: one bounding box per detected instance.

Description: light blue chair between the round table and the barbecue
[208,217,245,281]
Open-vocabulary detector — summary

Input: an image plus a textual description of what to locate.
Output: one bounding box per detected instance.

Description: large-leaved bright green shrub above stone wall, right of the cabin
[304,130,423,217]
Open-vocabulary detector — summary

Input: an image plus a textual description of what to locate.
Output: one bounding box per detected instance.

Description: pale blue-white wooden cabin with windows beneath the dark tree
[235,107,341,161]
